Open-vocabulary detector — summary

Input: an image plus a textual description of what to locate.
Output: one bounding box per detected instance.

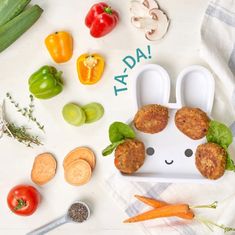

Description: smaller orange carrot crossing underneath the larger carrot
[135,195,194,219]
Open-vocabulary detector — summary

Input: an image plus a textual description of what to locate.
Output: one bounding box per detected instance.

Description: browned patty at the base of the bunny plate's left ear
[134,104,168,134]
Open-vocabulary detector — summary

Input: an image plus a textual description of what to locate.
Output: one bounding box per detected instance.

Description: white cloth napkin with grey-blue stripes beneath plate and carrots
[105,0,235,235]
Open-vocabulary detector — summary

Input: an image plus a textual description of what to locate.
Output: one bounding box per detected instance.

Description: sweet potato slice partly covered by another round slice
[63,147,95,170]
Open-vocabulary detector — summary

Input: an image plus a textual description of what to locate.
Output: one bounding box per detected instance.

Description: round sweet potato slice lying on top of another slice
[64,159,92,186]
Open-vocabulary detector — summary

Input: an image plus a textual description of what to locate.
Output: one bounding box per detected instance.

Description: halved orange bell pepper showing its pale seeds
[77,54,105,85]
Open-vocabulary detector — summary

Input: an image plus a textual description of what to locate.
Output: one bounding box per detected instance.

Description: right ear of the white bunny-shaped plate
[176,65,215,114]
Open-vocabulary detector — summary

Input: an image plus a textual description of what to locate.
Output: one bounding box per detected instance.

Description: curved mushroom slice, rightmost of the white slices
[145,8,169,41]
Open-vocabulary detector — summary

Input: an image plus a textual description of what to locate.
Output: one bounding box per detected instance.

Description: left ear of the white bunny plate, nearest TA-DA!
[133,64,170,108]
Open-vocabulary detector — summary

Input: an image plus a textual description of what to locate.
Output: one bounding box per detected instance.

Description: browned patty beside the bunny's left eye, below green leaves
[114,139,145,174]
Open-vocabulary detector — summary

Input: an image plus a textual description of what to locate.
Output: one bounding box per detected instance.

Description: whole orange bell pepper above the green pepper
[45,31,73,63]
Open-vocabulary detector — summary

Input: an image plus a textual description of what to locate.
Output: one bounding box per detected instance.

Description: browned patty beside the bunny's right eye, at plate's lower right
[196,143,227,180]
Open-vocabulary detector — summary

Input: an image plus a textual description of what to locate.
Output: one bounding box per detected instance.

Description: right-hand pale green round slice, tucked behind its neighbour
[82,103,104,123]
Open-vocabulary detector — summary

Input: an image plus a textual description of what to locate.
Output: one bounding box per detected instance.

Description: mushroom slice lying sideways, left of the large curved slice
[131,17,158,31]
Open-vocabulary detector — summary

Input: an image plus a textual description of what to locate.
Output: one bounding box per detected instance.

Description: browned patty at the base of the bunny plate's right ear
[175,107,210,140]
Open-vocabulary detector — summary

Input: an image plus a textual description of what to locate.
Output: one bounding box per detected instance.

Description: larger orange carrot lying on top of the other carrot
[124,204,190,223]
